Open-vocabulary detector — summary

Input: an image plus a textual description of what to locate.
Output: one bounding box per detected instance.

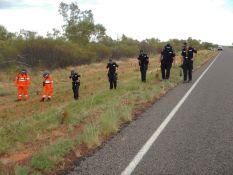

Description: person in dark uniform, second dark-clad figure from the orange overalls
[107,59,119,89]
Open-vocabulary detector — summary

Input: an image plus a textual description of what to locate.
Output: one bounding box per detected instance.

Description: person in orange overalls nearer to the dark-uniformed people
[40,72,53,102]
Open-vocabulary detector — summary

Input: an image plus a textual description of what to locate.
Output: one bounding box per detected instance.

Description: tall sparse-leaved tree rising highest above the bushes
[58,2,106,44]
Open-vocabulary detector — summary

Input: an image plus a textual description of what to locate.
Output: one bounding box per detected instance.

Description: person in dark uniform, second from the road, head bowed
[160,43,176,80]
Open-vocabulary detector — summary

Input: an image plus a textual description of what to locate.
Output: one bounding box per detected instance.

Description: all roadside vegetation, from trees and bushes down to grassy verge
[0,3,220,175]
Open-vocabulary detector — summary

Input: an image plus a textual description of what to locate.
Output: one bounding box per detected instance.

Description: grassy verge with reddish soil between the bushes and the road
[0,51,217,174]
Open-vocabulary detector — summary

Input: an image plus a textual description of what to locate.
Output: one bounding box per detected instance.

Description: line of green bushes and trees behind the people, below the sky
[0,2,217,69]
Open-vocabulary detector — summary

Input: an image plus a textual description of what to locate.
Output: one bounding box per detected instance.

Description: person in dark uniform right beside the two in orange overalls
[69,70,80,100]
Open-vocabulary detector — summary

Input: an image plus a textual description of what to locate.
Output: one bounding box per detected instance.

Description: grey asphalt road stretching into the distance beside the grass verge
[69,49,233,175]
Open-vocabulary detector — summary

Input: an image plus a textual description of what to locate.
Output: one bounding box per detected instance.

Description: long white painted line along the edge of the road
[121,54,220,175]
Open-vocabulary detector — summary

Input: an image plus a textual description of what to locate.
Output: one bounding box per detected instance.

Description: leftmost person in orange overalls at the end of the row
[15,69,30,101]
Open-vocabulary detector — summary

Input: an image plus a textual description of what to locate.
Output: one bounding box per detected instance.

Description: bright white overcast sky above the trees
[0,0,233,45]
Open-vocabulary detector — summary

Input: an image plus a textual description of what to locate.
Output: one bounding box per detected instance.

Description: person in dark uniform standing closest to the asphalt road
[181,43,197,83]
